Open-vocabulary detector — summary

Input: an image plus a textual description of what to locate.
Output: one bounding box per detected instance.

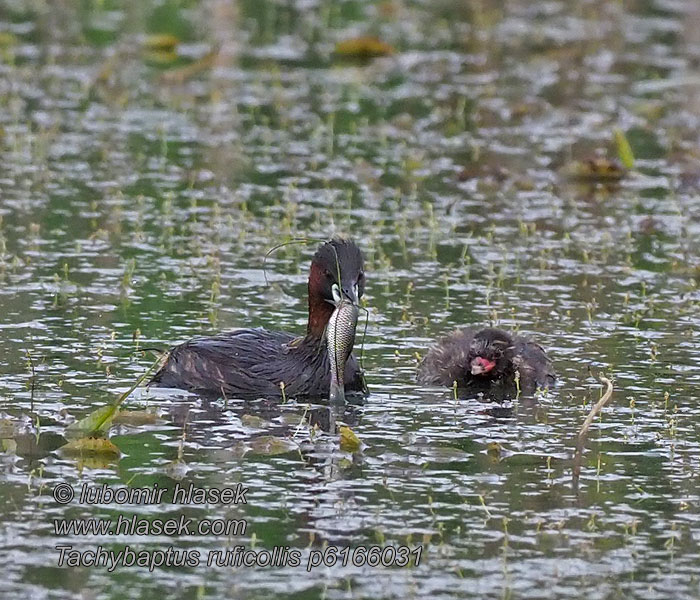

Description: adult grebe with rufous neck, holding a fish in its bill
[150,238,366,400]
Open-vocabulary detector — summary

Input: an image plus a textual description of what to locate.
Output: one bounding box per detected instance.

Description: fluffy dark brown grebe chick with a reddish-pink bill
[418,327,555,394]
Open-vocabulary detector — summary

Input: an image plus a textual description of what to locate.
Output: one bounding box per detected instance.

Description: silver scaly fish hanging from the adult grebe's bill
[326,301,359,402]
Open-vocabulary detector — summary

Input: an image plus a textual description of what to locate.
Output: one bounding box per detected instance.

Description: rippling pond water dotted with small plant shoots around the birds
[0,0,700,600]
